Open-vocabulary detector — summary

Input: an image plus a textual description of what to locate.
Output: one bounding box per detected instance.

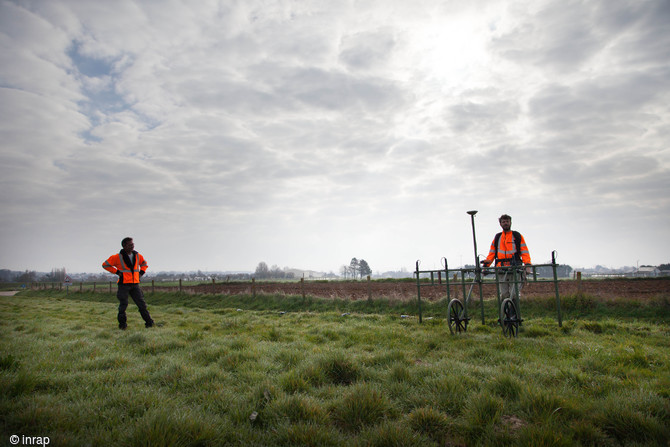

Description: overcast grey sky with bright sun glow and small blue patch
[0,0,670,273]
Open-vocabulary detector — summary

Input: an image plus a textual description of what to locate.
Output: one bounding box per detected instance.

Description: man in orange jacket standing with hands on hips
[102,237,154,329]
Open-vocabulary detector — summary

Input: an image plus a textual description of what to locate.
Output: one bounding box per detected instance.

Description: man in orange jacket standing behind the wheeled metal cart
[482,214,531,299]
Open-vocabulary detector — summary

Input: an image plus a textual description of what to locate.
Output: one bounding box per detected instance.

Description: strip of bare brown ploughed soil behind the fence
[178,277,670,301]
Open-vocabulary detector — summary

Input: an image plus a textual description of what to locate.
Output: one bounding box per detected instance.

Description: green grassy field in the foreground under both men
[0,290,670,446]
